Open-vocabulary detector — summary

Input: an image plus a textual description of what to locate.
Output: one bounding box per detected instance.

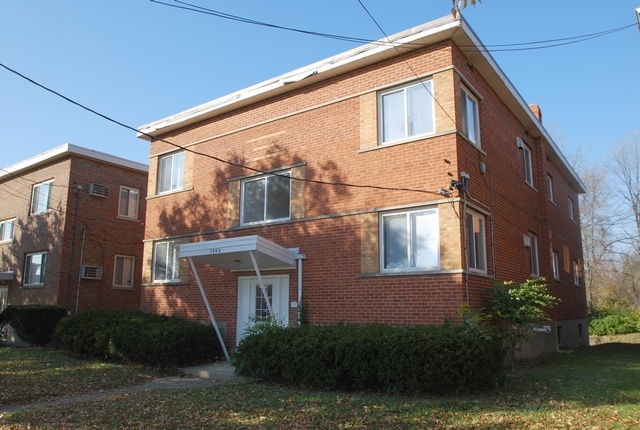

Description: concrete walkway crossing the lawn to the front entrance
[0,361,242,418]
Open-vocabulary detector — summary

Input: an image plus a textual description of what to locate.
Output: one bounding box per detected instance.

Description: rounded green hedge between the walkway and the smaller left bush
[54,310,222,368]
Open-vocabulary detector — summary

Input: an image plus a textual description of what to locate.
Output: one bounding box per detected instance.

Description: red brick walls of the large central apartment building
[141,38,584,341]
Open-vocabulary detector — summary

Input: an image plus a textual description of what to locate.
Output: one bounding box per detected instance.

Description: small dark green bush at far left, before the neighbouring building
[1,305,67,346]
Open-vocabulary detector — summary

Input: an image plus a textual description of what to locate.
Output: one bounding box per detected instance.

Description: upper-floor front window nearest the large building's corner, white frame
[378,79,435,144]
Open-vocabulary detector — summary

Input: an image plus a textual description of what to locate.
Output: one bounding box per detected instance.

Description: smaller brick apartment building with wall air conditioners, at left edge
[0,144,148,314]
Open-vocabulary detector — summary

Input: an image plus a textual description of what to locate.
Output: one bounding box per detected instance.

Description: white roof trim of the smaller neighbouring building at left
[0,143,149,179]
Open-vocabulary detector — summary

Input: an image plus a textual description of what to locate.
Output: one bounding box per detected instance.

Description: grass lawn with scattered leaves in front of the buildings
[0,343,640,430]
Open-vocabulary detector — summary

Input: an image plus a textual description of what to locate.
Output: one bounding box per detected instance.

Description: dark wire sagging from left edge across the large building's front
[0,63,439,195]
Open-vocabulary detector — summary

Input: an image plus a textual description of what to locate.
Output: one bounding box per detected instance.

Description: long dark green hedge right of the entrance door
[235,325,506,394]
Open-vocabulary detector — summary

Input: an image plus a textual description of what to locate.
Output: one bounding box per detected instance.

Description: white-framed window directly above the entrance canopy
[240,172,291,225]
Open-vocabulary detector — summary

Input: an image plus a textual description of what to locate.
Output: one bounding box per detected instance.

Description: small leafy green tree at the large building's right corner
[480,278,560,370]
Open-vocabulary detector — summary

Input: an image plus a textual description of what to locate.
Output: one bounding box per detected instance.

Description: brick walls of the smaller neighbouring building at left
[0,155,148,312]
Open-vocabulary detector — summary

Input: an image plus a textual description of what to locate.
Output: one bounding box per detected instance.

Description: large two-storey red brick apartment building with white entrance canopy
[139,17,588,356]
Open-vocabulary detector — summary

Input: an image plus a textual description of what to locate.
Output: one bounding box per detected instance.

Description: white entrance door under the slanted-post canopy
[236,275,289,345]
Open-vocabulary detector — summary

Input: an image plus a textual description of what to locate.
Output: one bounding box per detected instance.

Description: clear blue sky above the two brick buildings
[0,0,640,168]
